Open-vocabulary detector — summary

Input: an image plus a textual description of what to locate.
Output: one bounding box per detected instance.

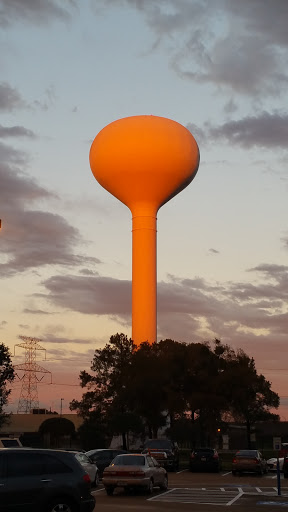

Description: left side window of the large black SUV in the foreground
[7,452,43,478]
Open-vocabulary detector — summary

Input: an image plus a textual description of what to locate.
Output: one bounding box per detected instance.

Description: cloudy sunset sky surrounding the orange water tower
[0,0,288,420]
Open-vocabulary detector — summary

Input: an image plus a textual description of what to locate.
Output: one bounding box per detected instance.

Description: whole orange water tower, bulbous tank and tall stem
[90,115,200,345]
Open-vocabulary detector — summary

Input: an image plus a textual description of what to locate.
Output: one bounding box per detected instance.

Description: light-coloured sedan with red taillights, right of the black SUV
[103,453,168,496]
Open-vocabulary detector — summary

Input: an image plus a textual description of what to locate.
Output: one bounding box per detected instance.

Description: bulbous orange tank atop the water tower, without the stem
[90,115,199,213]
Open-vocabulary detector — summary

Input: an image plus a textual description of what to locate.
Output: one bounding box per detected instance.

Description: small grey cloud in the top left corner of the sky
[0,0,76,27]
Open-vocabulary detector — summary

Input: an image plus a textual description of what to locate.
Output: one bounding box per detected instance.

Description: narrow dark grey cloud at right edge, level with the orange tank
[206,112,288,149]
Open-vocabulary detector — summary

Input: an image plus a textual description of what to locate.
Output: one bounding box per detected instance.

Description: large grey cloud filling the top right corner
[97,0,288,99]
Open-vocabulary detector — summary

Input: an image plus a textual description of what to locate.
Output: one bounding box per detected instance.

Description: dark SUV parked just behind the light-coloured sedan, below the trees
[142,439,179,471]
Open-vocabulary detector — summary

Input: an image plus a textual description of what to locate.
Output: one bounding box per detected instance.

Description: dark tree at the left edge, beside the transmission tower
[0,343,15,427]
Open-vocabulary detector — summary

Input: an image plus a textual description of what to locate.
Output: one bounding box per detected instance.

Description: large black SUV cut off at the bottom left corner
[0,448,95,512]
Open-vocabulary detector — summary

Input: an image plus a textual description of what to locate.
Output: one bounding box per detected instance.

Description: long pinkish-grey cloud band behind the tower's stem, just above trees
[37,264,288,341]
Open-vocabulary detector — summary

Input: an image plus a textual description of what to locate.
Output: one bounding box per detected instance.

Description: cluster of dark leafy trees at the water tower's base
[70,333,280,448]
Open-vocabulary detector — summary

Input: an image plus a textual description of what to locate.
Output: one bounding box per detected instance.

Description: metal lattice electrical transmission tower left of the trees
[14,336,52,413]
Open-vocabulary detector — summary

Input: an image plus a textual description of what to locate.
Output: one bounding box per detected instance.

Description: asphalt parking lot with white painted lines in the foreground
[93,470,288,512]
